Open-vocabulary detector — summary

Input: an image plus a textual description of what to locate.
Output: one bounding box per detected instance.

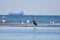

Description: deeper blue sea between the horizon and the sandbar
[0,15,60,23]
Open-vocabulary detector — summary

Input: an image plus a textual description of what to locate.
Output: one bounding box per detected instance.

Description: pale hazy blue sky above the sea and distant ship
[0,0,60,15]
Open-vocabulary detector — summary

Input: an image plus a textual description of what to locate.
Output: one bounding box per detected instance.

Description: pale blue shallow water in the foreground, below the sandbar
[0,27,60,40]
